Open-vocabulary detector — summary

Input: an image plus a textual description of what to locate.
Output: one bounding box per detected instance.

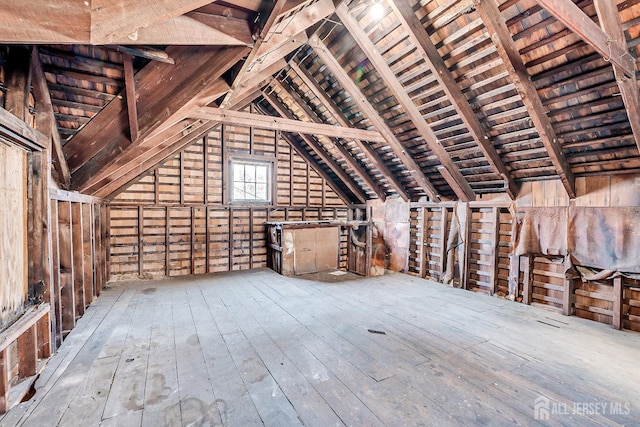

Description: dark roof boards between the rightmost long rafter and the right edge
[503,0,640,175]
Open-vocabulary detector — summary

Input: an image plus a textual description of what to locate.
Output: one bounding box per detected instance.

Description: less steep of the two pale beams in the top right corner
[536,0,636,77]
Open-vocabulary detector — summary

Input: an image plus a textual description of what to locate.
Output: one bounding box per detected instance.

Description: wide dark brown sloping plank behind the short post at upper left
[65,47,246,190]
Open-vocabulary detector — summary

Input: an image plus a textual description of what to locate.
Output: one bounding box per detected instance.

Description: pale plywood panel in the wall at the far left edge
[0,141,28,324]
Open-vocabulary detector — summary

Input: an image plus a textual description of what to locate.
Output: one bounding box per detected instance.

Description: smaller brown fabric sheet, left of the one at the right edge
[513,207,568,256]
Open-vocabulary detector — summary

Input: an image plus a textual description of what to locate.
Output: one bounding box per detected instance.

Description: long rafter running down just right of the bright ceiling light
[390,0,518,200]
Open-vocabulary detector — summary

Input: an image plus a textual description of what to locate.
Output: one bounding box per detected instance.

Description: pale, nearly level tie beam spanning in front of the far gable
[189,107,383,142]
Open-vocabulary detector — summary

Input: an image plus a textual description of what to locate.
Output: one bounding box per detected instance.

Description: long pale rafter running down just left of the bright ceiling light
[336,3,476,202]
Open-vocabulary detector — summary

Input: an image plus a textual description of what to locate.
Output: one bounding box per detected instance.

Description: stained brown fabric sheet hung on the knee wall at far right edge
[569,207,640,273]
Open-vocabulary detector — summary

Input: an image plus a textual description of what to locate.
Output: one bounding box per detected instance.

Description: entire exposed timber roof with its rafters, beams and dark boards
[0,0,640,202]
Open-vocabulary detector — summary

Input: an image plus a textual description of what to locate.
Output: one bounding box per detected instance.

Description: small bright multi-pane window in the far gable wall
[232,161,269,202]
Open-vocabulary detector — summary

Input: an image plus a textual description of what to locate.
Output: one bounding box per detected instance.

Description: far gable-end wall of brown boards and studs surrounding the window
[110,117,348,278]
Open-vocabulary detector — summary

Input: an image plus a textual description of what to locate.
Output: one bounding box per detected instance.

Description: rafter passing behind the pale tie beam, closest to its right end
[289,61,409,202]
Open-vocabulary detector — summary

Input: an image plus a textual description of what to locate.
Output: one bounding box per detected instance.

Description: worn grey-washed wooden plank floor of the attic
[0,269,640,426]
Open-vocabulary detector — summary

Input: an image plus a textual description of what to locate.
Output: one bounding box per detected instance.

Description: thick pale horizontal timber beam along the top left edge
[0,0,253,46]
